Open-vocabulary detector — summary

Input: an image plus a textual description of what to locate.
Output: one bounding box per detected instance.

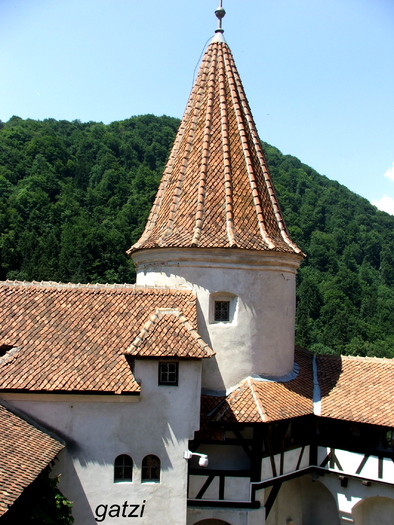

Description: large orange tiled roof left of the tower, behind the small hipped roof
[0,282,197,394]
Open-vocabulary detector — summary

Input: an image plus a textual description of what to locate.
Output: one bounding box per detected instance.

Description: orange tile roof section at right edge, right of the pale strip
[317,356,394,427]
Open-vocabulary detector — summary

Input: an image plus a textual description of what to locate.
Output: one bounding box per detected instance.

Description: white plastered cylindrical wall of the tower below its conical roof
[133,248,300,391]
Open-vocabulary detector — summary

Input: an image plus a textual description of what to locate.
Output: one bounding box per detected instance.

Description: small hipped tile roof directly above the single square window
[125,308,214,359]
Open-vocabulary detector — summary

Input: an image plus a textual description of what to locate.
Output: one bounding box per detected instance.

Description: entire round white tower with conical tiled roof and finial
[128,7,303,391]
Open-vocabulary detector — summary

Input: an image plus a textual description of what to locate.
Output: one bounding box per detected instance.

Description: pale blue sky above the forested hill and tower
[0,0,394,214]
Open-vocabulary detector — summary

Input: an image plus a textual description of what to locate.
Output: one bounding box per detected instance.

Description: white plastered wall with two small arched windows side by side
[2,360,205,525]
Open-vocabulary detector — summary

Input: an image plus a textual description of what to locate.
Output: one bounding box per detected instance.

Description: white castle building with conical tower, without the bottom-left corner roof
[0,4,394,525]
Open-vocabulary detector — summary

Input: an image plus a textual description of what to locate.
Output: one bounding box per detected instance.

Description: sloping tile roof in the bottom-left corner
[0,405,64,516]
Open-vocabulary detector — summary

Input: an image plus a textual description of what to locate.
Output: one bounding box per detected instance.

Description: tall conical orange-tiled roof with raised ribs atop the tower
[128,33,303,256]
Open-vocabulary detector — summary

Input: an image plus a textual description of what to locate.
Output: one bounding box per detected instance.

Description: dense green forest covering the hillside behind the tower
[0,115,394,358]
